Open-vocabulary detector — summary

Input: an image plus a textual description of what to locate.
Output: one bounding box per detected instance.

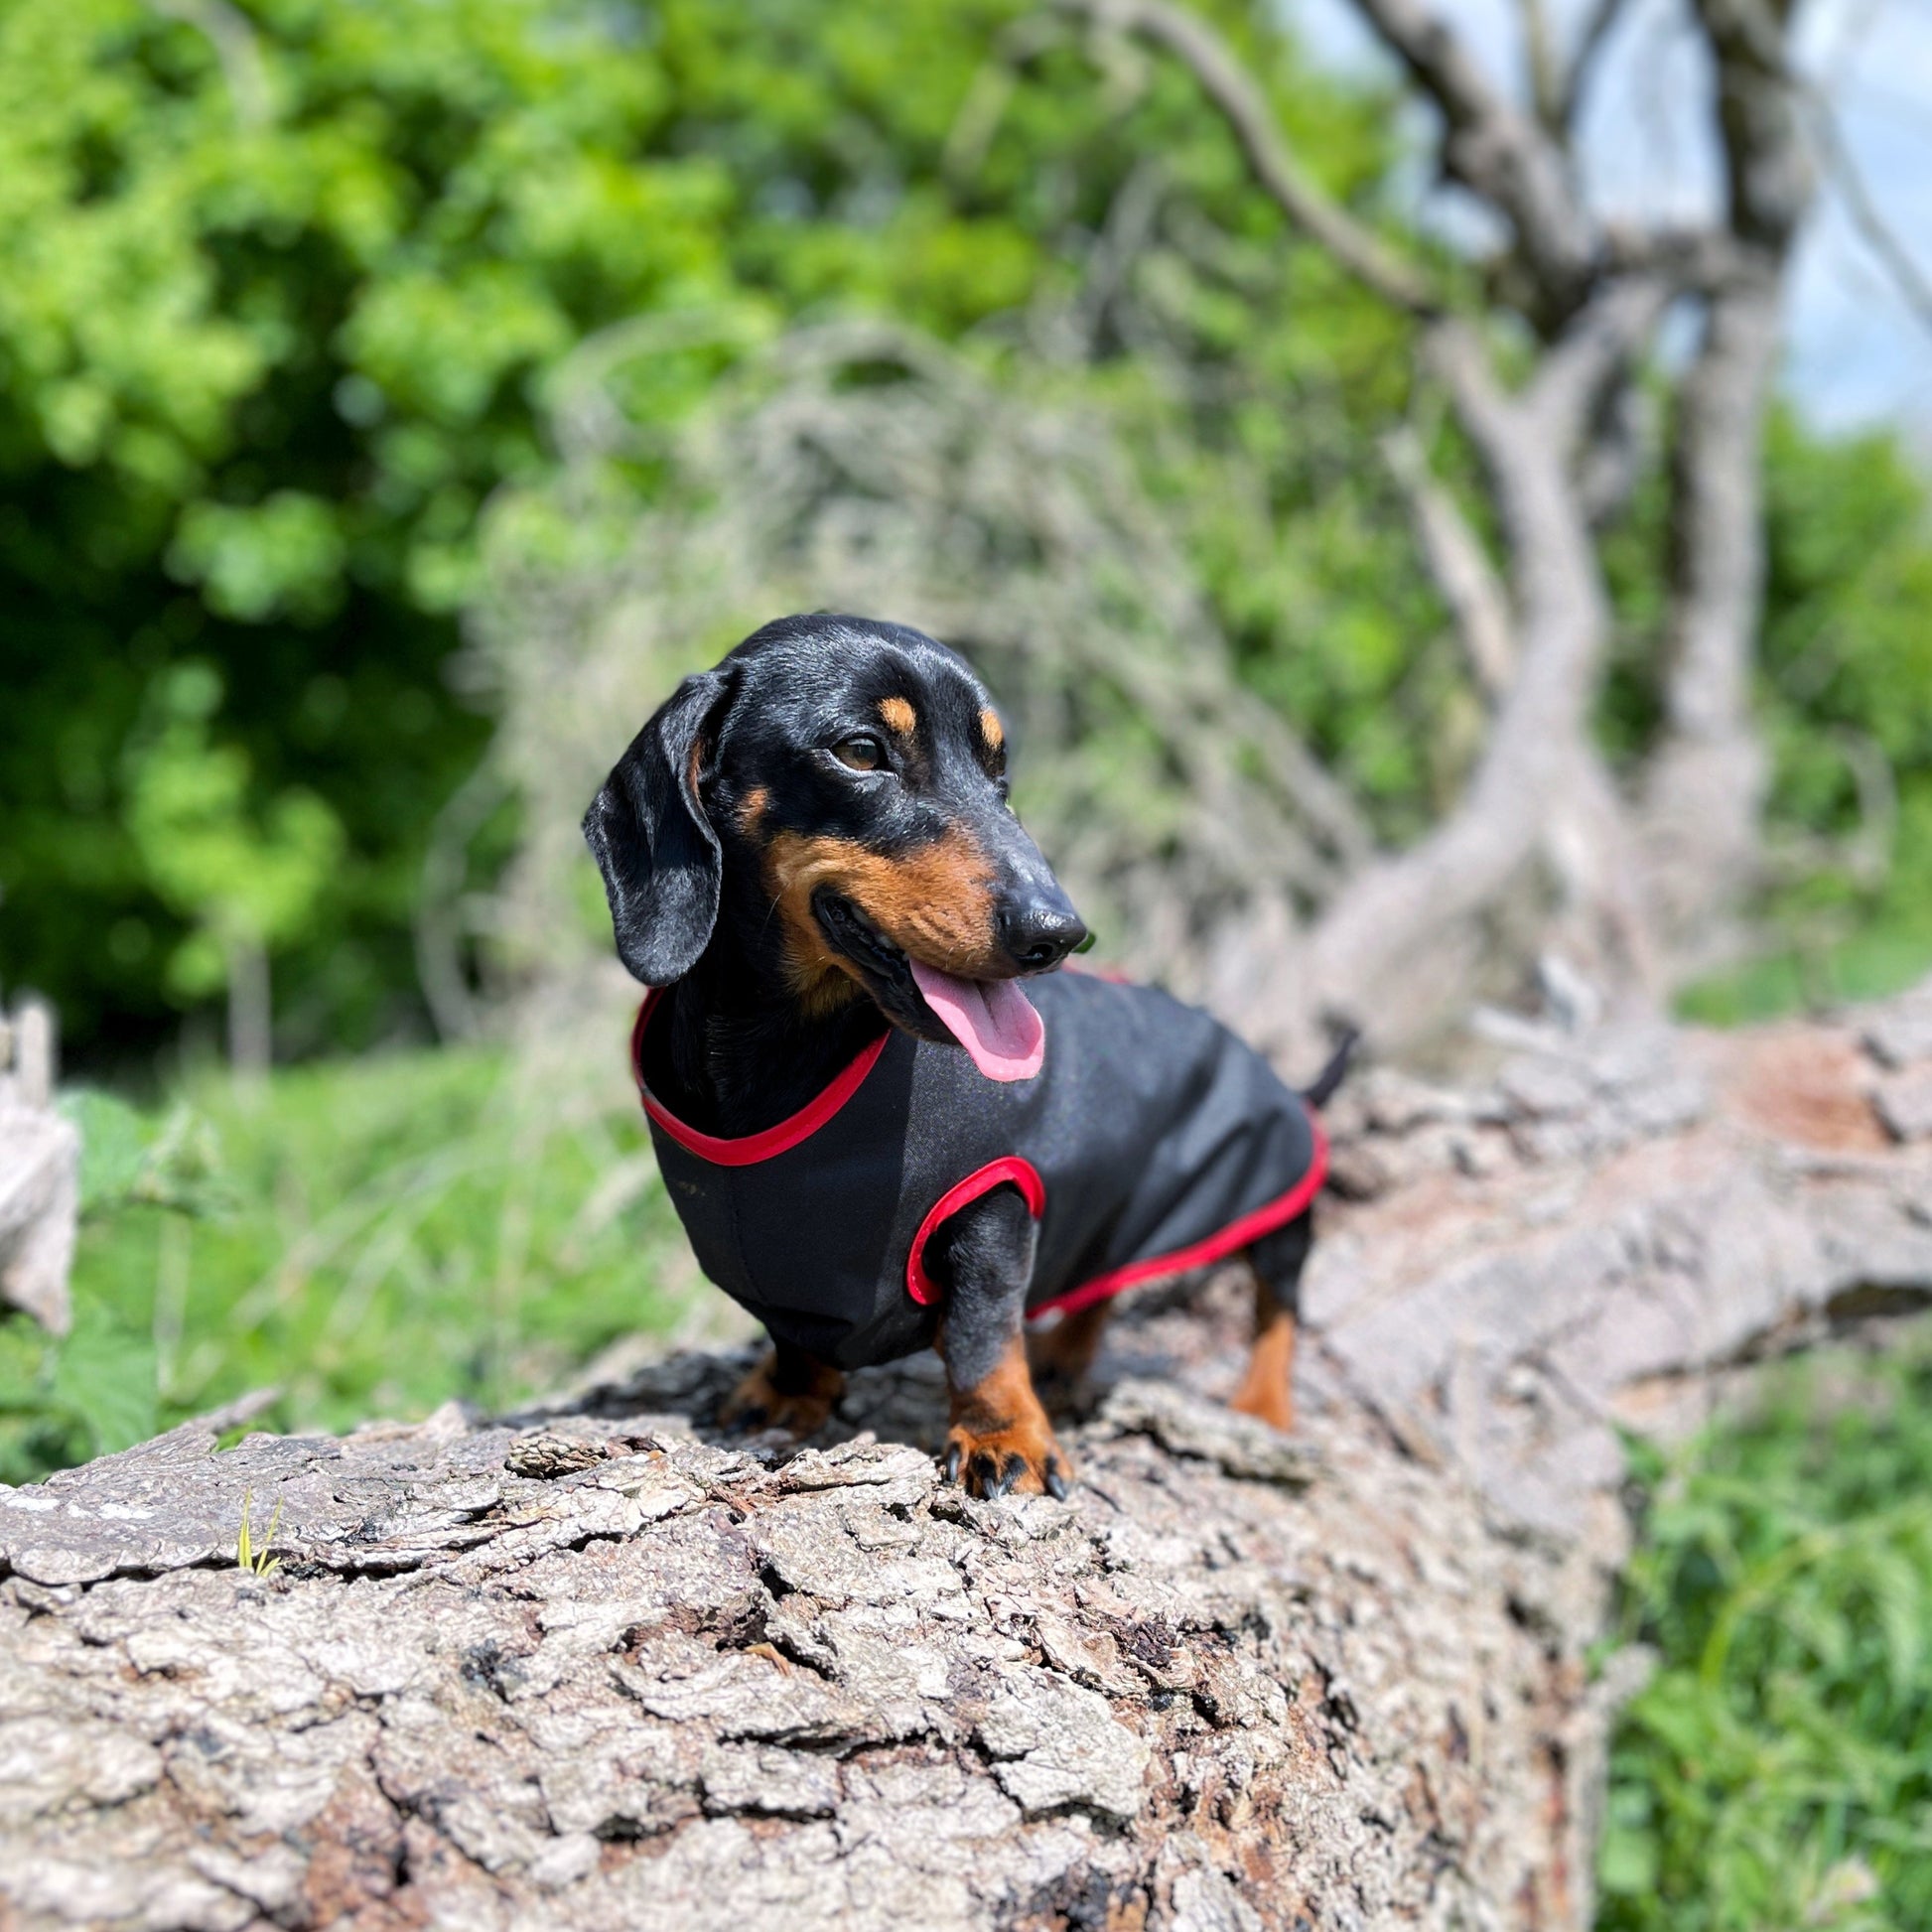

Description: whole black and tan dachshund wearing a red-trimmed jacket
[584,617,1339,1495]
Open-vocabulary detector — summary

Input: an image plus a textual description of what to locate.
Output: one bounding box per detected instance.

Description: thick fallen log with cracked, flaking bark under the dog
[0,985,1932,1932]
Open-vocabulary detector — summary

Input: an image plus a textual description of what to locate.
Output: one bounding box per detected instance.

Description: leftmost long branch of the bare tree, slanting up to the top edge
[1051,0,1442,315]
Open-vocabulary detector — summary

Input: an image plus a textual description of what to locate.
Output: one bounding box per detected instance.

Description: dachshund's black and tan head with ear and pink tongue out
[584,617,1086,1080]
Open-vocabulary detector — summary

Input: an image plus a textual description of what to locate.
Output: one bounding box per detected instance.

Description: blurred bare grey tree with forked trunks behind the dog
[1028,0,1839,1042]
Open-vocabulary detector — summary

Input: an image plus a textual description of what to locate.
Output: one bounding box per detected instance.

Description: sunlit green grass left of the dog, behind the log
[0,1049,692,1482]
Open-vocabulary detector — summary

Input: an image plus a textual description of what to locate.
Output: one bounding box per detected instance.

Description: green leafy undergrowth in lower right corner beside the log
[1597,1333,1932,1932]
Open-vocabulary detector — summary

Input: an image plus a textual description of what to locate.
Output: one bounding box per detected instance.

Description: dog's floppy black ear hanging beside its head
[584,666,736,985]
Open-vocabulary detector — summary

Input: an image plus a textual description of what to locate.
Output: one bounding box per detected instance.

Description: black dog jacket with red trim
[631,972,1327,1368]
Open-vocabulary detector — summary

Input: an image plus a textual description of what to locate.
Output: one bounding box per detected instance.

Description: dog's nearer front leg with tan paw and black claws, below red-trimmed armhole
[927,1186,1072,1495]
